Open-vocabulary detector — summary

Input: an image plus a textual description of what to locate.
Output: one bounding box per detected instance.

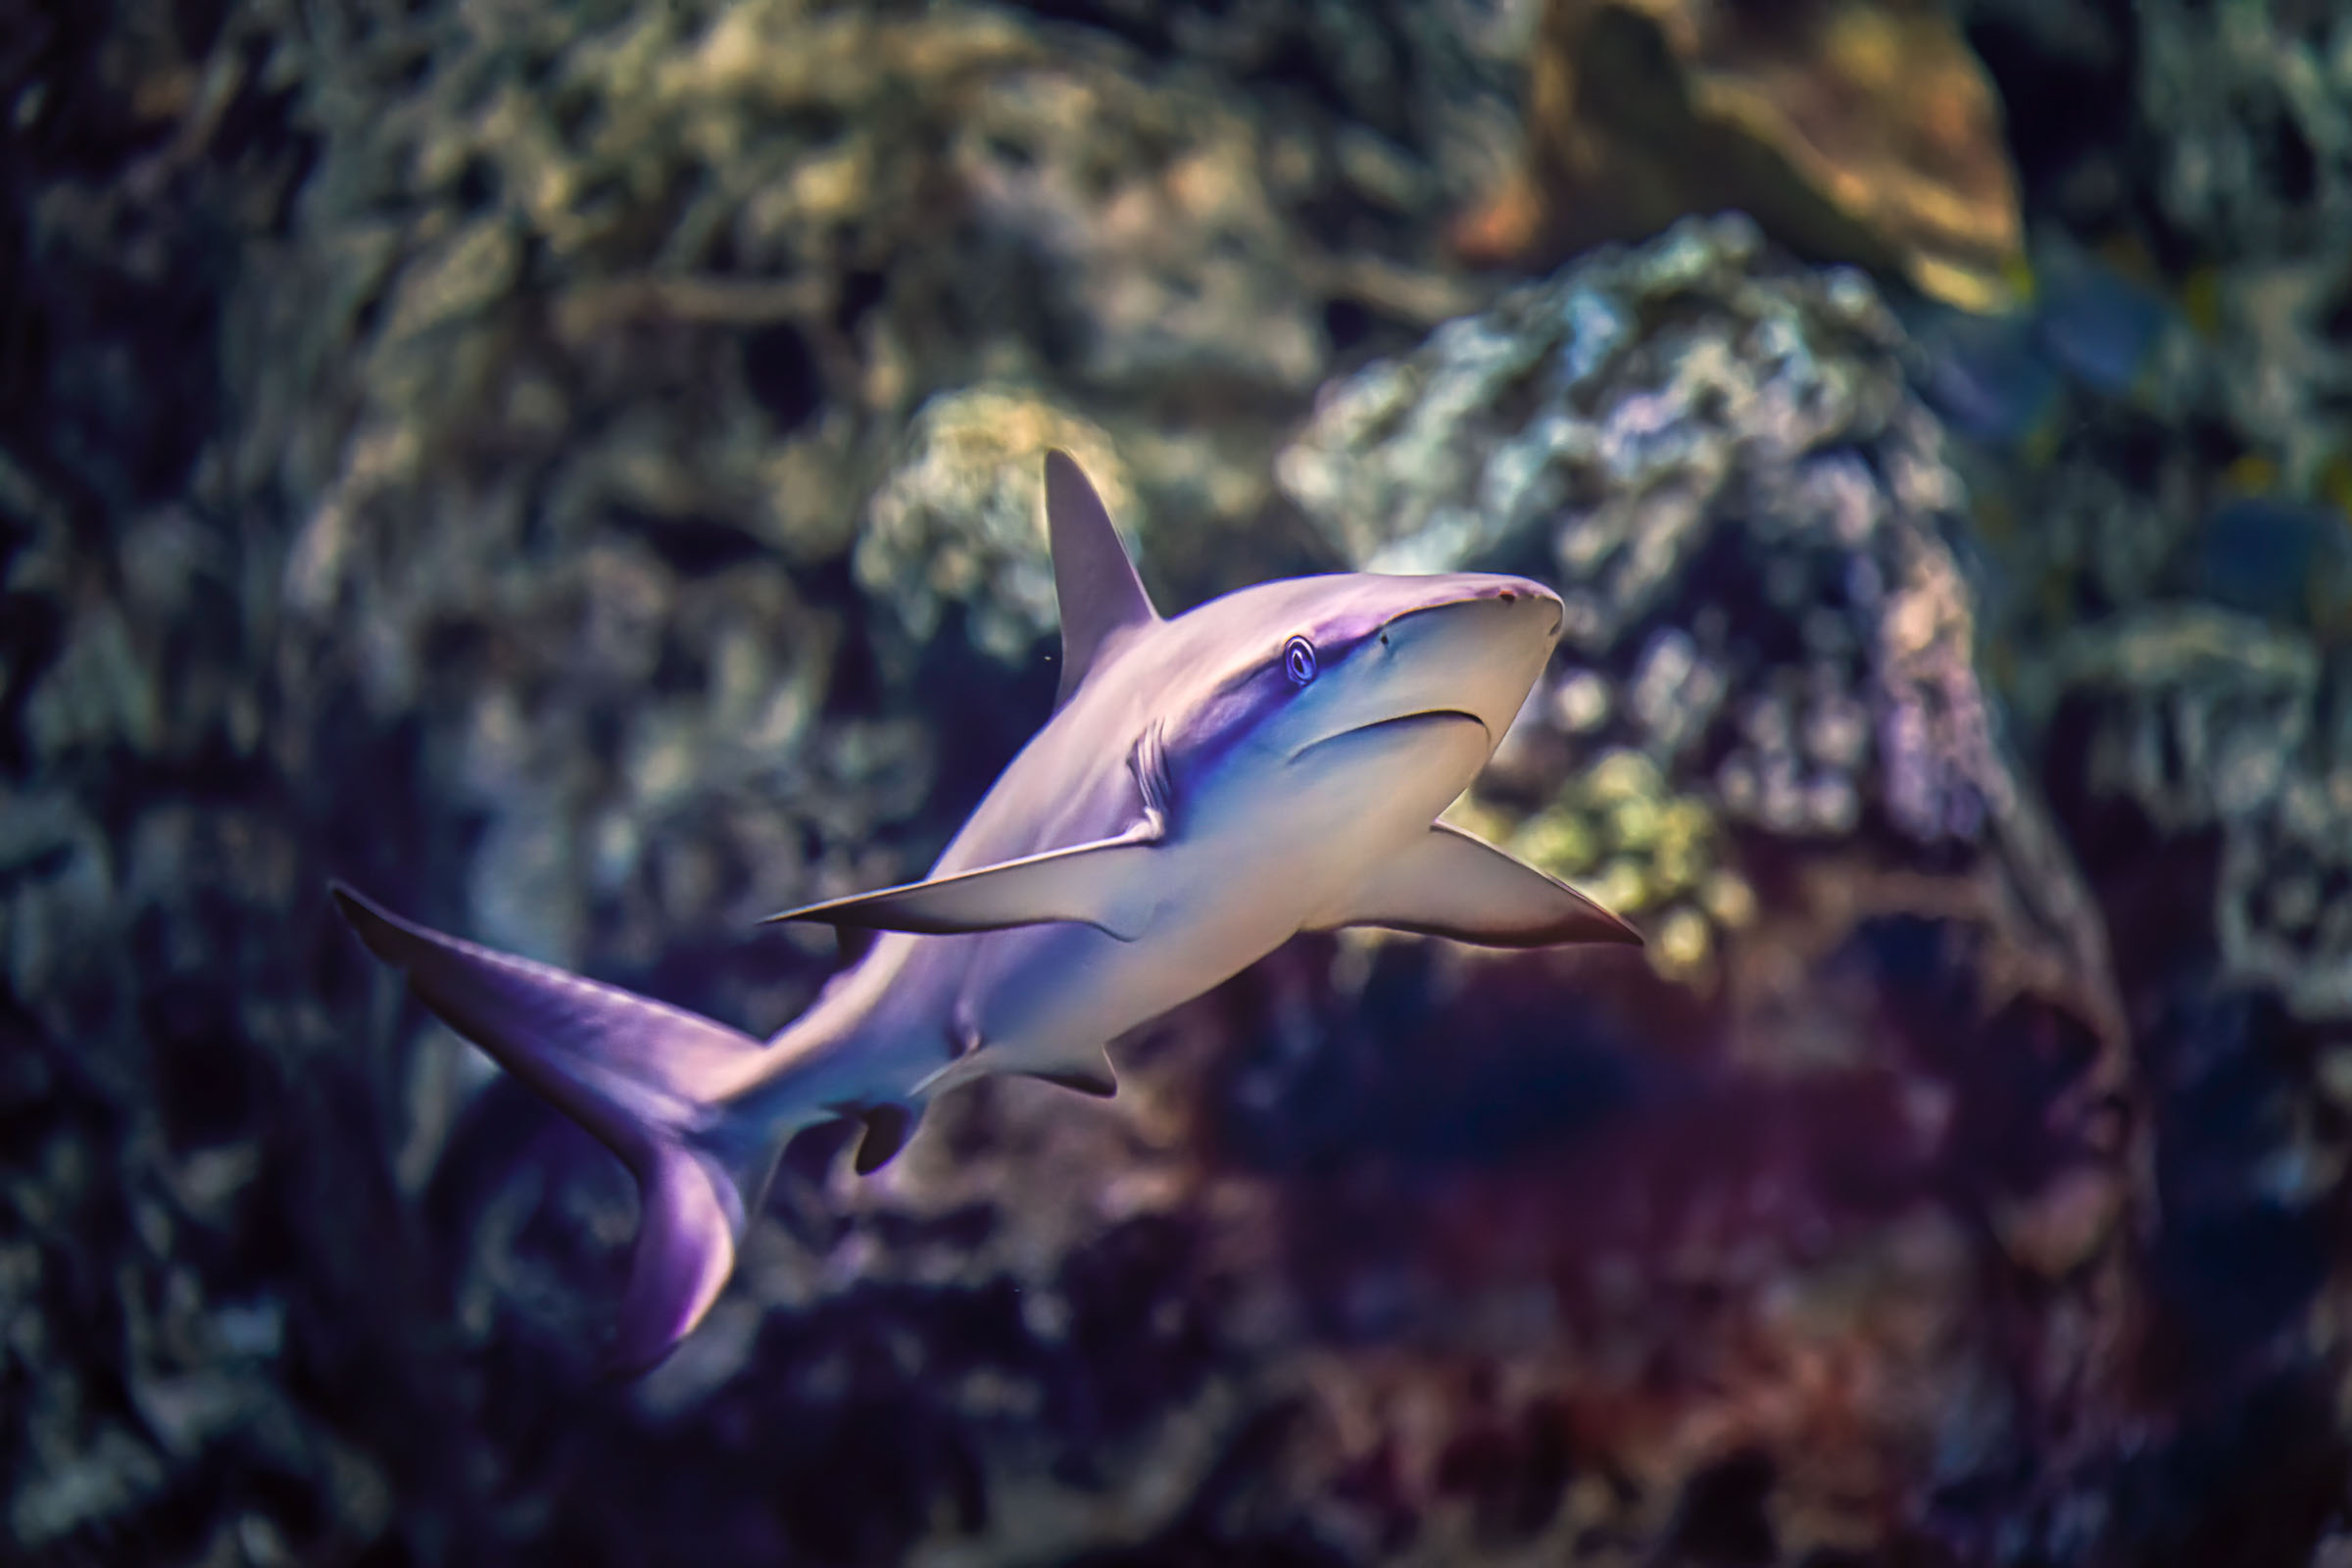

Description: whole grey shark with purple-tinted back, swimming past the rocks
[334,452,1642,1371]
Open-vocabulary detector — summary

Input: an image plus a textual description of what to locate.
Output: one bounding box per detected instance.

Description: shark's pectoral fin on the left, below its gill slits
[760,815,1159,943]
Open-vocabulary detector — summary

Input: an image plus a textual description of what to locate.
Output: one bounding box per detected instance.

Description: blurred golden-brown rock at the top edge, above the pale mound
[1456,0,2025,311]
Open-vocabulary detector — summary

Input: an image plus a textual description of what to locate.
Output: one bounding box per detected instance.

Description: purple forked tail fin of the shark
[334,884,783,1373]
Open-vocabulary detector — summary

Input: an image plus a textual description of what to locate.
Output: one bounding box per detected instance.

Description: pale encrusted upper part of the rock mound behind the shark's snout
[1277,219,2117,1039]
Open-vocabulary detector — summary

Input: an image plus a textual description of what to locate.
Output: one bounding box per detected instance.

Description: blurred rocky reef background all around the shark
[0,0,2352,1568]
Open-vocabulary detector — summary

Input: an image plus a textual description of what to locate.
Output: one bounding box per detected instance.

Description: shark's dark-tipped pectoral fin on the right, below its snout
[1310,823,1642,948]
